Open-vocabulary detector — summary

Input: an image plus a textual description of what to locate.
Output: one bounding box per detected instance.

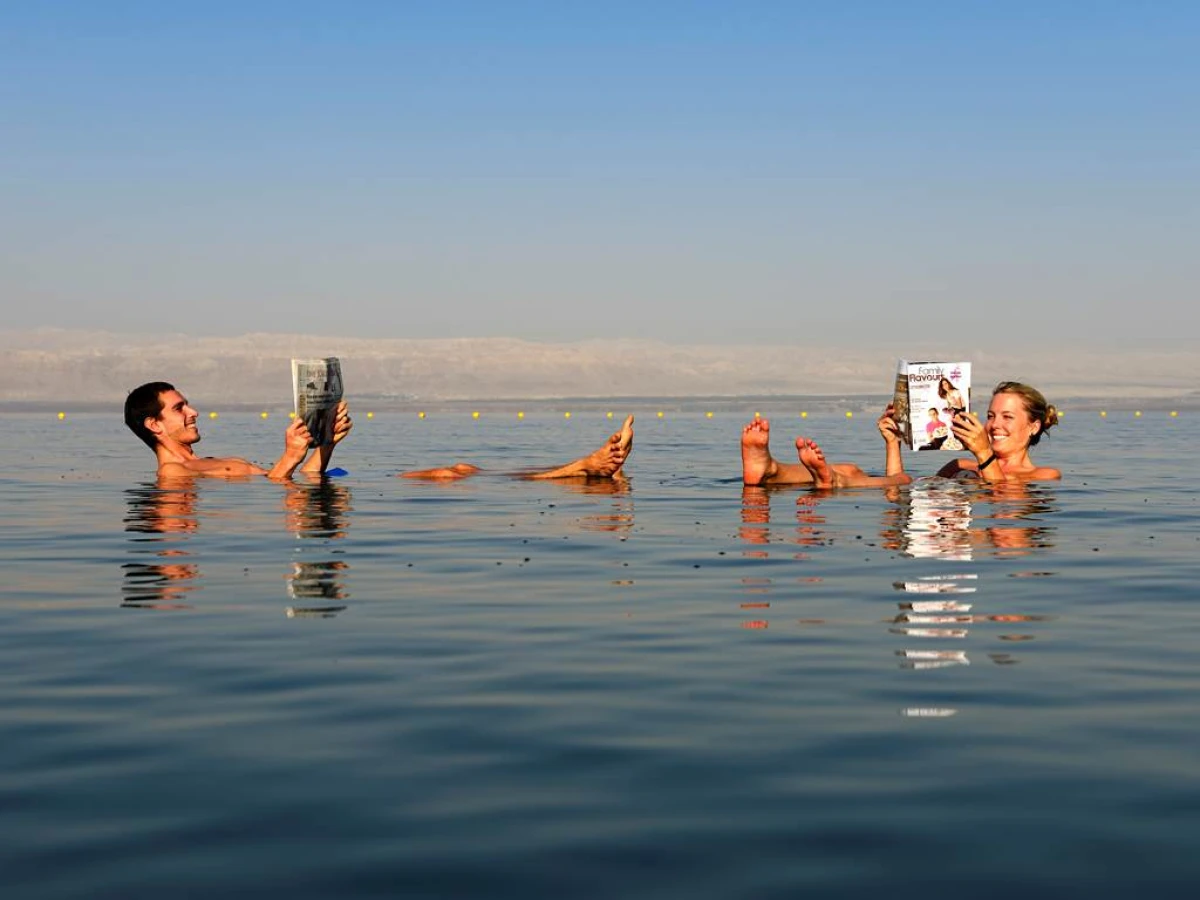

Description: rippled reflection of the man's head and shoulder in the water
[121,476,199,610]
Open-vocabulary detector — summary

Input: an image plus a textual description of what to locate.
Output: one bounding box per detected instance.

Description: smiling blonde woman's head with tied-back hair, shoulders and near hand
[937,382,1062,482]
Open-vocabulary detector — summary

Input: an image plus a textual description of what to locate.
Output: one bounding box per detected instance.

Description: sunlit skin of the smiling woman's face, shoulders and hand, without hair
[937,392,1062,482]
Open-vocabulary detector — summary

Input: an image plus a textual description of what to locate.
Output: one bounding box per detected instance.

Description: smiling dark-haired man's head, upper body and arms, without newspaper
[125,382,353,481]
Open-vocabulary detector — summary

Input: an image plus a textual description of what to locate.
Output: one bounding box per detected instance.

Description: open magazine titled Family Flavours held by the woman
[892,360,971,450]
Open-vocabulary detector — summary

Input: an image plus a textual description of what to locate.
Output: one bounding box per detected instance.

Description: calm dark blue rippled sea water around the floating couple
[0,404,1200,900]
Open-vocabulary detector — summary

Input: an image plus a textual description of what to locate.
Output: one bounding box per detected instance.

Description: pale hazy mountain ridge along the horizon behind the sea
[0,329,1200,403]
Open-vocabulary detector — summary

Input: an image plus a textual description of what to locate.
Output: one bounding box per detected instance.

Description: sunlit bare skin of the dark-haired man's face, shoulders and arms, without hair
[145,390,353,481]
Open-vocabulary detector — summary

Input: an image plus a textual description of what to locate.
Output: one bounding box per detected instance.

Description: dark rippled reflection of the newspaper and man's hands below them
[284,479,350,618]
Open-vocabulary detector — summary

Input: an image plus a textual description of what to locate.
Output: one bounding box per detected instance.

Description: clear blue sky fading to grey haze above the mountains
[0,2,1200,349]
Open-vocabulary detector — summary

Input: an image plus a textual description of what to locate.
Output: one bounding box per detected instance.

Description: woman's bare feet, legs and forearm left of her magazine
[742,404,912,487]
